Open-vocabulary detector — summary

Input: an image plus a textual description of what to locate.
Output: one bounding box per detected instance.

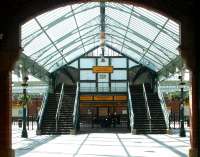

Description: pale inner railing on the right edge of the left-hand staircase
[72,82,79,130]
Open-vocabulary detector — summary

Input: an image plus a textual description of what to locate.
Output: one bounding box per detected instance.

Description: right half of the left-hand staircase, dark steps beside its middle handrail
[57,86,76,134]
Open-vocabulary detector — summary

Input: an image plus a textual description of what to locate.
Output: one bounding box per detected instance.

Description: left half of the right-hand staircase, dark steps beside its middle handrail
[130,85,150,134]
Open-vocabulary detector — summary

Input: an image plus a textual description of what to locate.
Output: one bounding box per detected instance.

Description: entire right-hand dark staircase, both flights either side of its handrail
[131,84,166,134]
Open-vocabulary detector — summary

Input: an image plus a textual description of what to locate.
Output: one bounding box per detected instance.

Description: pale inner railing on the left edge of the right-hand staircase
[128,83,134,132]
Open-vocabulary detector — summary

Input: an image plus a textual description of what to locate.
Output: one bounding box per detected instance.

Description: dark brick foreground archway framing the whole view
[0,0,195,156]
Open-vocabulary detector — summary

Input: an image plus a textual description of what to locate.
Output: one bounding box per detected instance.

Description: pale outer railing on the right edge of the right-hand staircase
[158,82,169,129]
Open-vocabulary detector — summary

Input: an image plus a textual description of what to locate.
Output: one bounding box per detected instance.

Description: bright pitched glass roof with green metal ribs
[21,2,179,72]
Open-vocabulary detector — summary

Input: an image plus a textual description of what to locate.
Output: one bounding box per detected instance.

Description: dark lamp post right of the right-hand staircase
[179,76,186,137]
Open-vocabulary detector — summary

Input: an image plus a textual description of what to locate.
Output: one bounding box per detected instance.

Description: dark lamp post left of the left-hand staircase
[21,76,28,138]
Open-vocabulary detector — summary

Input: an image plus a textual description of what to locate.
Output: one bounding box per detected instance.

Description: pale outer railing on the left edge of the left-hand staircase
[37,88,49,130]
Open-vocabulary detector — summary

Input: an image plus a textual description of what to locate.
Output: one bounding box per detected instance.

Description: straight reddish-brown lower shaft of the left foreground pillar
[0,70,14,157]
